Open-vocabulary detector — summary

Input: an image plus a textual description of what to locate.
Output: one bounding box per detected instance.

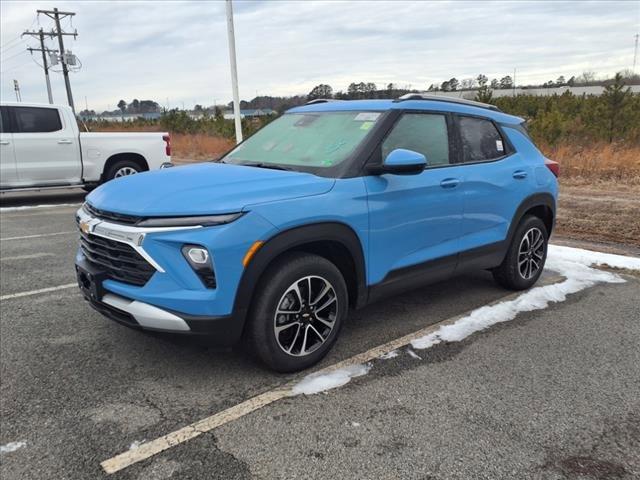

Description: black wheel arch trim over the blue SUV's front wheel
[233,222,367,334]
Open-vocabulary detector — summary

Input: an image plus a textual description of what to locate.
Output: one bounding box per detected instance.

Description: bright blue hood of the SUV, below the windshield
[87,163,335,217]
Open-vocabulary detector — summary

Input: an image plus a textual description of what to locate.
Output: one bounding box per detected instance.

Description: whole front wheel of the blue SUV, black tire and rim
[246,252,348,372]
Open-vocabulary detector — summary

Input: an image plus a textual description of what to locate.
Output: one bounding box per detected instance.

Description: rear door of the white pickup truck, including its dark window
[11,107,82,186]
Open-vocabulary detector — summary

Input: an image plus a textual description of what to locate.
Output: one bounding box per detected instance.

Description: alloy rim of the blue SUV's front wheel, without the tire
[274,275,338,357]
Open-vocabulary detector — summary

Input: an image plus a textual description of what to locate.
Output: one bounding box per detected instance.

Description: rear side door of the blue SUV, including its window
[456,116,531,256]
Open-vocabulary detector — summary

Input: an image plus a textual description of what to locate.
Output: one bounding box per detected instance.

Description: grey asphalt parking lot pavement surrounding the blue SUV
[0,189,640,480]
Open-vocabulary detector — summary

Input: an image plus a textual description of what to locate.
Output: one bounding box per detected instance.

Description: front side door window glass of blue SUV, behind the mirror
[382,113,449,166]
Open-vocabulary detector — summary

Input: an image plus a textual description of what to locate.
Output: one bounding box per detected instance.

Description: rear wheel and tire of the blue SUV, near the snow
[492,215,549,290]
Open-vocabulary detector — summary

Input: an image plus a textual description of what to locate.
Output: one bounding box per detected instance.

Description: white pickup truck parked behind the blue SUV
[0,102,171,192]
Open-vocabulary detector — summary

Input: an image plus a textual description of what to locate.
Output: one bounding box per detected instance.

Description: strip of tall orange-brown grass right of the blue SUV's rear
[540,143,640,185]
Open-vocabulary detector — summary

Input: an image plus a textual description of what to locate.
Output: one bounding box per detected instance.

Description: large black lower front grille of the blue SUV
[80,232,156,287]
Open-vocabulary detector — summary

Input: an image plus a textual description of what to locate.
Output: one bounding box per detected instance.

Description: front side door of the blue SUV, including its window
[365,112,463,285]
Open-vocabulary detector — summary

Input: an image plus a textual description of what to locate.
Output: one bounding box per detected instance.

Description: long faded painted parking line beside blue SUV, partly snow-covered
[100,277,560,474]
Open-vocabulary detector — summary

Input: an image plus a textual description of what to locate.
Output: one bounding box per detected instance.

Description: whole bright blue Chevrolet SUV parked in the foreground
[76,94,558,372]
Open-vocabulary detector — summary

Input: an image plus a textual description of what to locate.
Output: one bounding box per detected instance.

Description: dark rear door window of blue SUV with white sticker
[460,117,505,162]
